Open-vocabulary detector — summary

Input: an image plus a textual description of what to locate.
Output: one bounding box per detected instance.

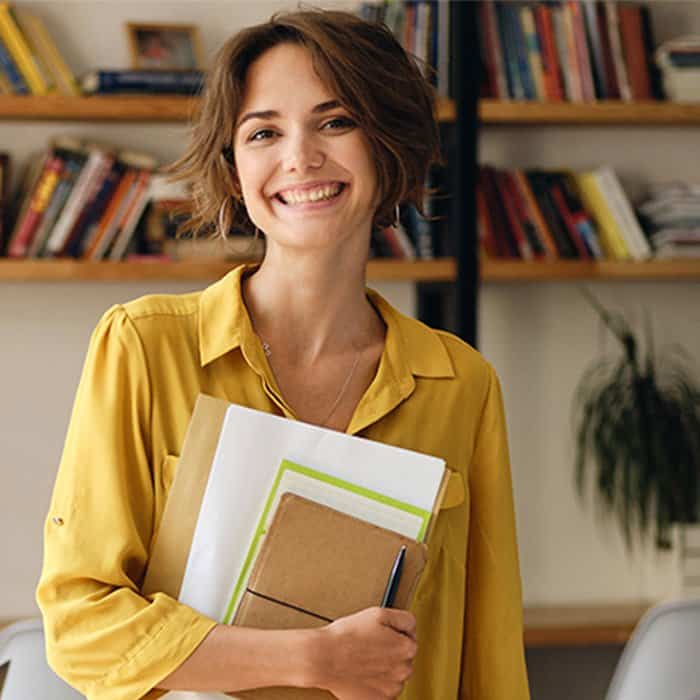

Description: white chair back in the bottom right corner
[606,600,700,700]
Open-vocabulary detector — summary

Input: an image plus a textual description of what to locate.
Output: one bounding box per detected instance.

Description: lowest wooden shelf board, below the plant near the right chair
[523,603,650,647]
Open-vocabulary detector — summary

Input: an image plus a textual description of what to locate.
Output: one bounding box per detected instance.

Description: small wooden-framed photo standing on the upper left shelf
[126,22,202,70]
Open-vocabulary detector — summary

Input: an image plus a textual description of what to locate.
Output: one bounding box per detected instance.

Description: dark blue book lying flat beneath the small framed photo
[81,70,204,95]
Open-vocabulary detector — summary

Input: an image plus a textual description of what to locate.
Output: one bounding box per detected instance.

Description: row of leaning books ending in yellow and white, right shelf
[476,166,652,260]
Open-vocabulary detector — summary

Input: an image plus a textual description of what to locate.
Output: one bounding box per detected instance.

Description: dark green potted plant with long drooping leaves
[574,289,700,549]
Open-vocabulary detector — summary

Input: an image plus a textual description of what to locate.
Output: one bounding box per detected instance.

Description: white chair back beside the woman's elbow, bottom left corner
[0,620,84,700]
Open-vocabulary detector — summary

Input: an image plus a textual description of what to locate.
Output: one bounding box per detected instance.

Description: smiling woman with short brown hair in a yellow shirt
[37,10,528,700]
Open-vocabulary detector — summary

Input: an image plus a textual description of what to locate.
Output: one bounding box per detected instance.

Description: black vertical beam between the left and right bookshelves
[450,0,481,346]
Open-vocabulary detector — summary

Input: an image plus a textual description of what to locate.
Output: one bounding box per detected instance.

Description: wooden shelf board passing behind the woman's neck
[0,258,457,282]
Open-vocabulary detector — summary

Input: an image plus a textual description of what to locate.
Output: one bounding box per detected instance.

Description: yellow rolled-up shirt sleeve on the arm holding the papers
[37,306,215,700]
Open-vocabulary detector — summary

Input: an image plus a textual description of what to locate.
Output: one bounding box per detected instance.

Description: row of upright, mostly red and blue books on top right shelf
[479,0,663,102]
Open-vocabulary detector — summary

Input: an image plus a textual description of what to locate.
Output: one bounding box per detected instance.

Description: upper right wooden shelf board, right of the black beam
[479,100,700,126]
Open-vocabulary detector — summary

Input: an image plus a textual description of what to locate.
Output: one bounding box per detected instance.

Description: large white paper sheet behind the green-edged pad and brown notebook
[167,405,445,700]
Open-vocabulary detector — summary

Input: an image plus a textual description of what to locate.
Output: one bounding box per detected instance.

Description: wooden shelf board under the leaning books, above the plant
[481,258,700,282]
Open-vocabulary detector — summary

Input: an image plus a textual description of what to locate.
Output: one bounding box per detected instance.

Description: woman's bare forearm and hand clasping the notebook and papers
[158,608,417,700]
